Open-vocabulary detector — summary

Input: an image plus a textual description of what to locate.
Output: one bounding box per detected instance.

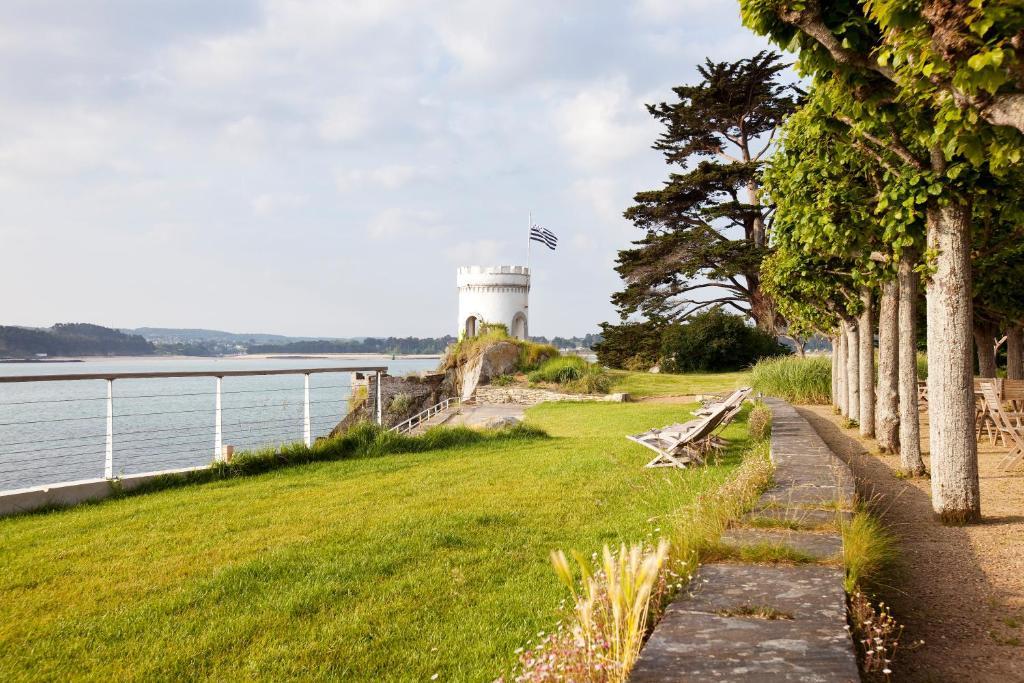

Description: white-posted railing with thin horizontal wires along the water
[0,366,387,488]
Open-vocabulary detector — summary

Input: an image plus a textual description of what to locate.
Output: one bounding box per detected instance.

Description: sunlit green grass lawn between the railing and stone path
[0,401,745,681]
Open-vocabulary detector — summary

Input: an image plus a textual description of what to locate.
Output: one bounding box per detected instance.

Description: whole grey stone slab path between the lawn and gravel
[630,399,859,682]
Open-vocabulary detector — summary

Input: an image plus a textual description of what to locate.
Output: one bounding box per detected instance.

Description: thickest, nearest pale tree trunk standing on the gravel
[927,198,981,524]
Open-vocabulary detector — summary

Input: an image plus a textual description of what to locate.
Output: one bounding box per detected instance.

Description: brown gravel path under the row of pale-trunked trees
[799,405,1024,681]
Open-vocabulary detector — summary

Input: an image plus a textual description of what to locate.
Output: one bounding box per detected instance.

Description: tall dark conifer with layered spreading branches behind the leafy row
[612,52,799,334]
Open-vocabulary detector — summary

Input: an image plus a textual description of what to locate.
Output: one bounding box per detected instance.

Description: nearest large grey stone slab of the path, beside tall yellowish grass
[630,564,859,683]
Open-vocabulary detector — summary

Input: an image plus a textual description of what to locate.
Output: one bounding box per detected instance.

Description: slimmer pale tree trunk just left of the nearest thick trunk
[896,254,925,476]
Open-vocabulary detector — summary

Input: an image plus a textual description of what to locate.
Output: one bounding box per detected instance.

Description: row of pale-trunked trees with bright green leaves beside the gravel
[740,0,1024,523]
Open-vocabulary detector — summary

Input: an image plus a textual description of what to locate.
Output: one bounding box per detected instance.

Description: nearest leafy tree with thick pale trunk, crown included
[741,0,1024,523]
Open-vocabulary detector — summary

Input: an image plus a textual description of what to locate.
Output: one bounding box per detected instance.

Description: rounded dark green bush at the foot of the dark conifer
[662,307,790,373]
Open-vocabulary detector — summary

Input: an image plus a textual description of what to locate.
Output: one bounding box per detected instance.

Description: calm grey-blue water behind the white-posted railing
[0,356,437,490]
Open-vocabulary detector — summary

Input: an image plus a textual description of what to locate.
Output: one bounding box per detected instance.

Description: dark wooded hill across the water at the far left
[0,323,157,358]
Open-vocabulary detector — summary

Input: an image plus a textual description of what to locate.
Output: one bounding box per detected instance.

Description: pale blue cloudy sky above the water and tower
[0,0,767,337]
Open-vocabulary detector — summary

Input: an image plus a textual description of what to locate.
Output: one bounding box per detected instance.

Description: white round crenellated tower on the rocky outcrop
[458,265,529,339]
